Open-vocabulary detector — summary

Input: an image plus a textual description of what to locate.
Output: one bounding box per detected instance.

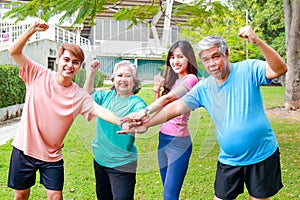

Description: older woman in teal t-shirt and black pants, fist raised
[84,61,146,200]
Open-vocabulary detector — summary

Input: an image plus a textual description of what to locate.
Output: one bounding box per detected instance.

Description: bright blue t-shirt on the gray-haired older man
[183,60,278,166]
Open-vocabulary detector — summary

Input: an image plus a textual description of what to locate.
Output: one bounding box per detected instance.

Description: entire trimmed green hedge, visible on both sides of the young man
[0,65,104,108]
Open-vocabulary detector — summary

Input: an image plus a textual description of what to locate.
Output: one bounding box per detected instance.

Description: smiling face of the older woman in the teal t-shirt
[113,65,135,97]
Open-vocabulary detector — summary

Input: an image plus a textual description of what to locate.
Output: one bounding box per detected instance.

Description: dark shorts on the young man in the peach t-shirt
[8,147,64,191]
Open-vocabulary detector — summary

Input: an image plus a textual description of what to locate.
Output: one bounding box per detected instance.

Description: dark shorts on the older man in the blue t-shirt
[215,149,283,199]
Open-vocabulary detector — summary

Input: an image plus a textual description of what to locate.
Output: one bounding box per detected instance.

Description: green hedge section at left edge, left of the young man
[0,65,26,108]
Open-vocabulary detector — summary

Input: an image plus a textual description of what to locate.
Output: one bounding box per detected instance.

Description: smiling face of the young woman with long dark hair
[170,48,189,77]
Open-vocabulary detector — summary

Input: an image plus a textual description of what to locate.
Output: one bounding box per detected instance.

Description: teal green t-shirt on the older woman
[92,90,146,168]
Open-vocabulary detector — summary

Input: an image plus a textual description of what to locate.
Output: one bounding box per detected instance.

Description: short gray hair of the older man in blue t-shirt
[197,36,228,56]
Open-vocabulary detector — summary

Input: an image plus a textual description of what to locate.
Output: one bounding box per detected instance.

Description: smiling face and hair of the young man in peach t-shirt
[56,50,82,83]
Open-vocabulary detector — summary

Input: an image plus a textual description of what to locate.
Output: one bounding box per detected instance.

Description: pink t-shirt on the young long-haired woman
[160,74,198,137]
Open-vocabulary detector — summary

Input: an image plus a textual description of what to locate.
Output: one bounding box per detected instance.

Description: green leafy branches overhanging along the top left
[3,0,162,25]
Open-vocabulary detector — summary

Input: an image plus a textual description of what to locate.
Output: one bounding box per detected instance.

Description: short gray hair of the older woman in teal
[111,60,141,94]
